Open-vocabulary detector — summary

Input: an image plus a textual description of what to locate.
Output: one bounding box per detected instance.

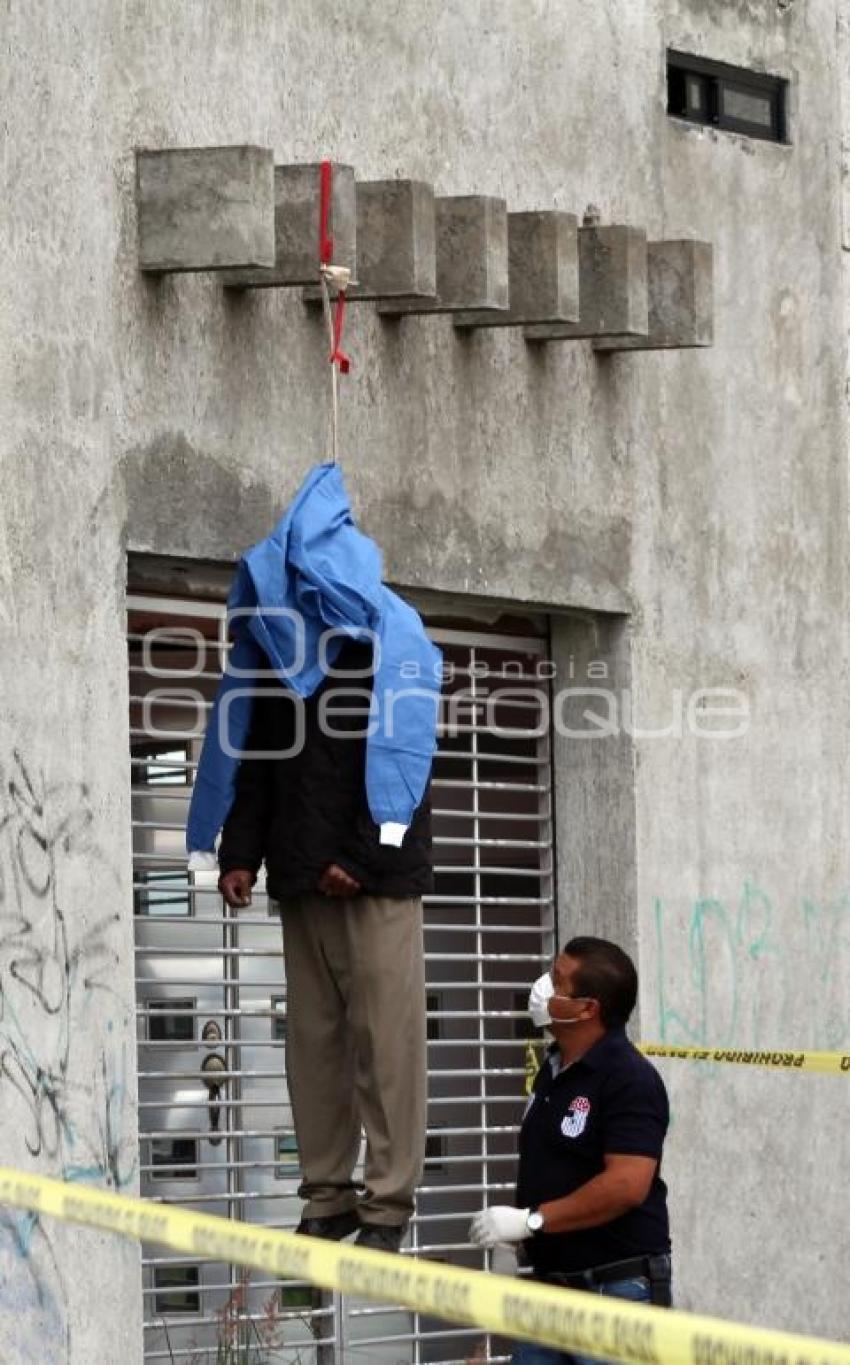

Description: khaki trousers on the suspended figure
[280,894,427,1224]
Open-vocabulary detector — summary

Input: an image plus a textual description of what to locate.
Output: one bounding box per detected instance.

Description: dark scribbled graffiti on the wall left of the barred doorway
[0,751,136,1362]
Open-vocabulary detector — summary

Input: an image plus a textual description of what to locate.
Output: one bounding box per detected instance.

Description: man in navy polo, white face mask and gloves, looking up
[472,938,670,1365]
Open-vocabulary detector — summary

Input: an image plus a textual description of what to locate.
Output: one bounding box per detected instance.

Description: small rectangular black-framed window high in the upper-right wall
[667,52,789,142]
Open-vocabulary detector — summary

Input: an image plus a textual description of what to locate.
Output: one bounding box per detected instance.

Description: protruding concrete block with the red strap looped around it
[222,162,356,289]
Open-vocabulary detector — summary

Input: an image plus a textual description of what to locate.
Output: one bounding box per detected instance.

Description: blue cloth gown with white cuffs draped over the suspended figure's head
[187,464,442,865]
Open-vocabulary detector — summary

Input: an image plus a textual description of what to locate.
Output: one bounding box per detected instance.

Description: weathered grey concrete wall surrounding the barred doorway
[0,0,850,1362]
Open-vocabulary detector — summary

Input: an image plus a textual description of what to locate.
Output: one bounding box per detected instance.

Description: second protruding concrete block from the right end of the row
[525,225,649,341]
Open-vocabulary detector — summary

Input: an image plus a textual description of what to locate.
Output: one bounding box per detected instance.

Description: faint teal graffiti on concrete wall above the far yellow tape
[654,880,850,1050]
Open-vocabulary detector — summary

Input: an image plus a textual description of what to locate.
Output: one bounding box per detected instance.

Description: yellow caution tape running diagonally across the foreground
[0,1167,850,1365]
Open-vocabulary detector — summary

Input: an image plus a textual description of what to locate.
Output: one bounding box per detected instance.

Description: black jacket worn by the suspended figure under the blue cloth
[218,642,433,901]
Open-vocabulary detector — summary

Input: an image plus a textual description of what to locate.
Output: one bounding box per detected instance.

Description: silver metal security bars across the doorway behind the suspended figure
[128,594,554,1365]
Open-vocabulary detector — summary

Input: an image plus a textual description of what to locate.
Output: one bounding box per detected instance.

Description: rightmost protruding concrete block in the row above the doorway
[593,242,714,351]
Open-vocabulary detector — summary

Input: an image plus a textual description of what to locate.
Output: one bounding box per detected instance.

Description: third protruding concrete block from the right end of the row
[454,209,578,328]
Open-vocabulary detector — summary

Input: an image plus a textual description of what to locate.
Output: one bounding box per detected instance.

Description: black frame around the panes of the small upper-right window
[667,48,790,146]
